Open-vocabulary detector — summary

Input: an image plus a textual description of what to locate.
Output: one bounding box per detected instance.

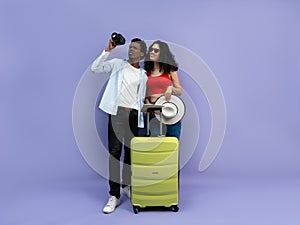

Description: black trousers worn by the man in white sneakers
[108,107,138,198]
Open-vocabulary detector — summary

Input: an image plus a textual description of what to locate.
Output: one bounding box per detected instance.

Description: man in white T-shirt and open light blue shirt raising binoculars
[91,34,147,213]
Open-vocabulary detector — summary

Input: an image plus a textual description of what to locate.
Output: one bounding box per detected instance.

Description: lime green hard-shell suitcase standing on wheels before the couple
[131,106,179,213]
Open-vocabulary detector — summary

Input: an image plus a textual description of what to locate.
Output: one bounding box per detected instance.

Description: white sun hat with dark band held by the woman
[155,95,185,125]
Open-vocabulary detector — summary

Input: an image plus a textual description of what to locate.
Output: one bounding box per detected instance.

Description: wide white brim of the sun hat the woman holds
[155,95,185,125]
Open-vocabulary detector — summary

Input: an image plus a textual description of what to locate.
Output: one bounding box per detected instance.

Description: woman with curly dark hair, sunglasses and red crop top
[144,40,182,140]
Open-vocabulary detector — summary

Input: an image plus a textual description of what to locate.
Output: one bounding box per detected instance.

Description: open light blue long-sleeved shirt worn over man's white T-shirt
[91,50,148,128]
